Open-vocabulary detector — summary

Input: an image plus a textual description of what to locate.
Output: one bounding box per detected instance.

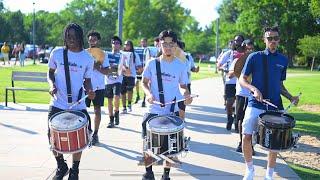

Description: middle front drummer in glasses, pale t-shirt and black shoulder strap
[142,30,192,180]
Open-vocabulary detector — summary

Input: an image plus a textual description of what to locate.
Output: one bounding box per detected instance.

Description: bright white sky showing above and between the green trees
[3,0,222,27]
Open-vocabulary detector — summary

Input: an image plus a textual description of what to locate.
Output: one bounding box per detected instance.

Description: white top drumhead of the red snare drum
[49,111,88,131]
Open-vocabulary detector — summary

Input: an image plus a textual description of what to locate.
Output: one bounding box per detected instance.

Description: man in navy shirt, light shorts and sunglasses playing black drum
[240,27,299,180]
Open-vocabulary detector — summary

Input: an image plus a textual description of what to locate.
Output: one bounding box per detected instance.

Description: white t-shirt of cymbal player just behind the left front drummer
[89,49,110,90]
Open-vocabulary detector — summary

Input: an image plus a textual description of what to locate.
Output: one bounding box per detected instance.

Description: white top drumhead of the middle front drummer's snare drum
[147,115,185,133]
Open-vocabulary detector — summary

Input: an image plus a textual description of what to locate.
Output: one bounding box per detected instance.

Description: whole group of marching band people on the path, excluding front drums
[43,23,299,180]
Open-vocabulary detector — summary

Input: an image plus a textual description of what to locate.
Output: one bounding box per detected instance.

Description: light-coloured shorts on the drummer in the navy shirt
[242,107,265,134]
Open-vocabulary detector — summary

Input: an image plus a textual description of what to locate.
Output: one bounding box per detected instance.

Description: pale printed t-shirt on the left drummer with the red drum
[48,47,94,110]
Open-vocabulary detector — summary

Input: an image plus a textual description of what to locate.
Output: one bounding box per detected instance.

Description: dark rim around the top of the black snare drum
[259,111,296,129]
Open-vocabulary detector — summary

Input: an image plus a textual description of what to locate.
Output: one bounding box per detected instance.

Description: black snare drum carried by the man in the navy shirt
[257,112,295,151]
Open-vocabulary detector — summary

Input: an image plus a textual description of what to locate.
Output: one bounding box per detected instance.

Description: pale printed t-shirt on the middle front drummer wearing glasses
[142,58,188,115]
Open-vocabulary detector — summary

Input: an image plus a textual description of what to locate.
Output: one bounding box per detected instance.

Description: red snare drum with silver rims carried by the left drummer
[49,110,89,153]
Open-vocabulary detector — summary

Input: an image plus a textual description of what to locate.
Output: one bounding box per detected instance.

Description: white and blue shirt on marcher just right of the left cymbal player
[105,52,124,84]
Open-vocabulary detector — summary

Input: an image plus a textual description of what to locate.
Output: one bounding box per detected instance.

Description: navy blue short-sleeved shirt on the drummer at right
[242,49,288,110]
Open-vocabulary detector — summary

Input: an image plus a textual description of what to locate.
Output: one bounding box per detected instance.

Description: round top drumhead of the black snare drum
[259,111,295,129]
